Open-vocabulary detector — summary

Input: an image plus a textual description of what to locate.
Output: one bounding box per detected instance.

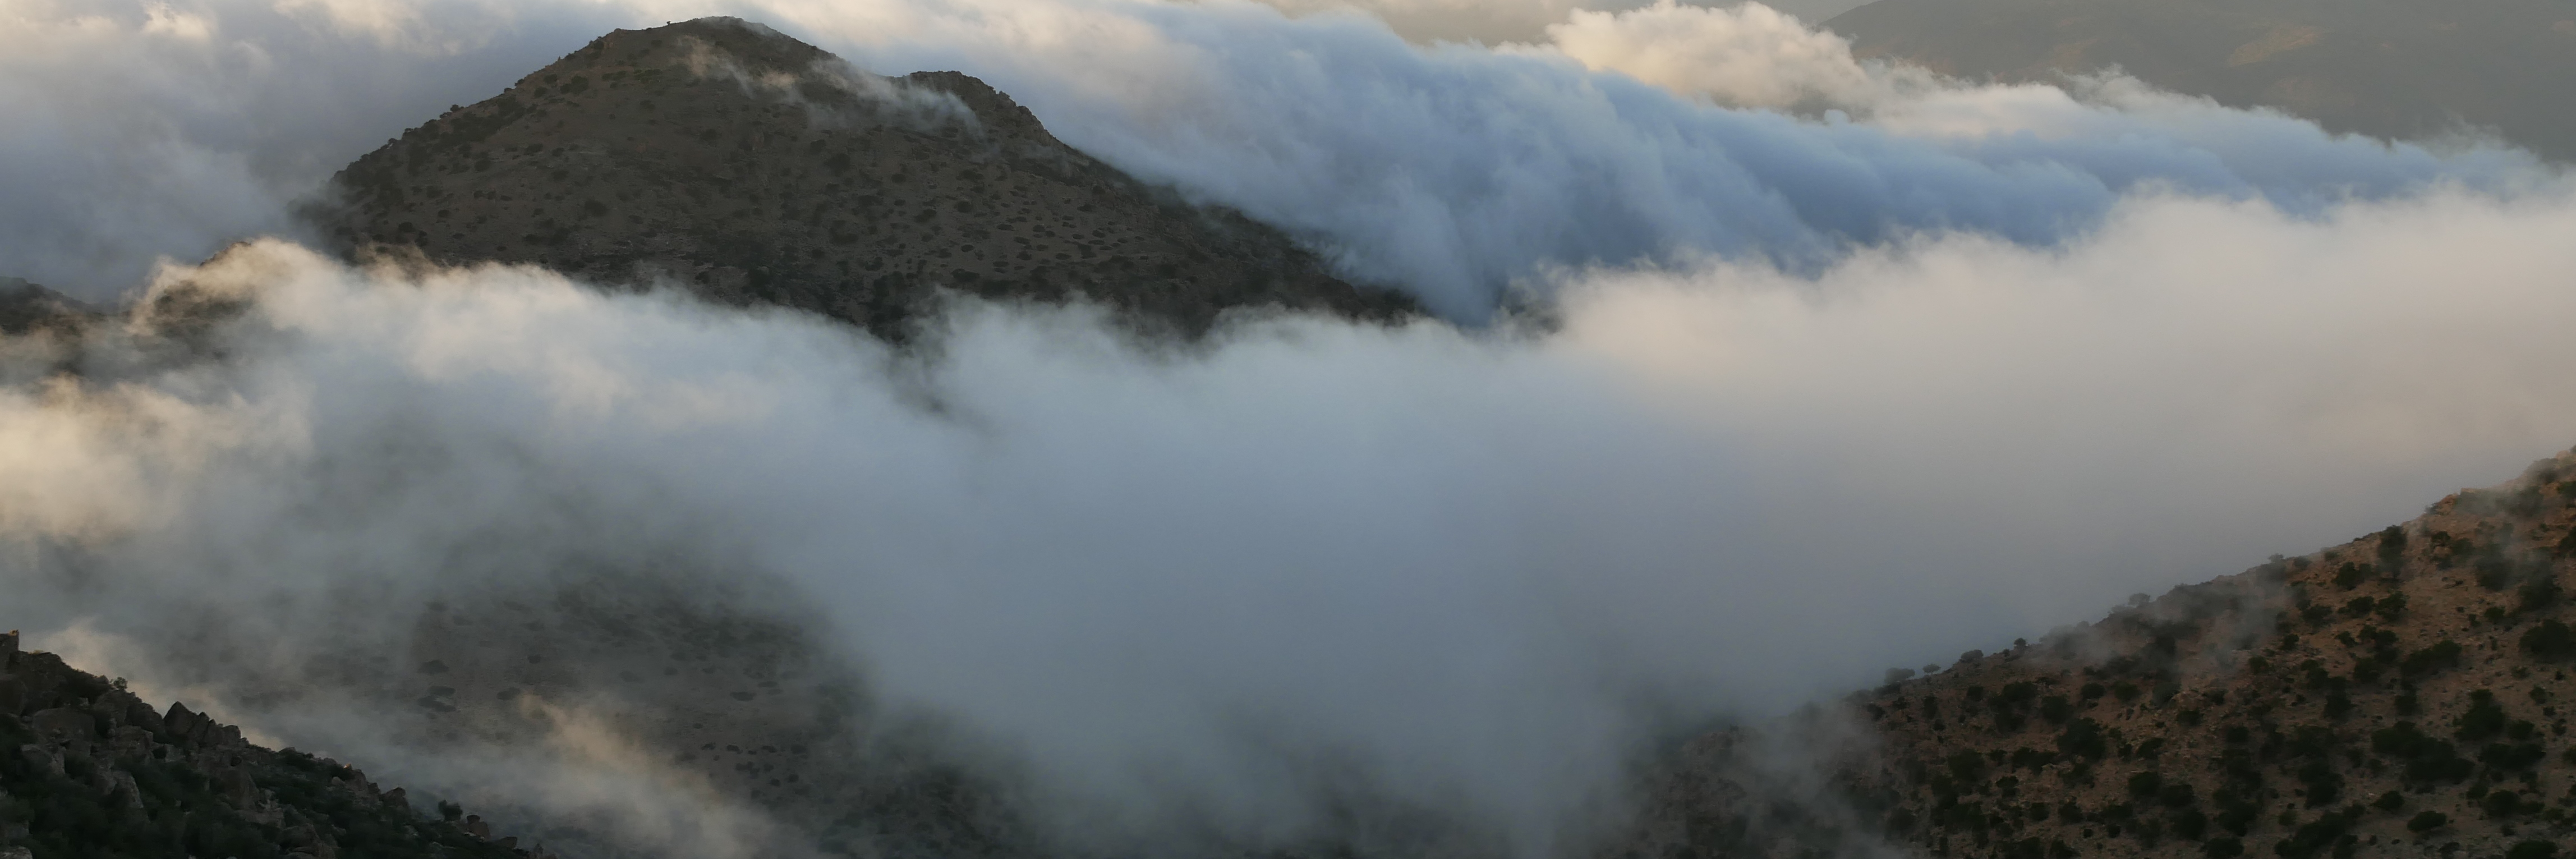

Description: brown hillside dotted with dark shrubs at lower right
[1636,452,2576,859]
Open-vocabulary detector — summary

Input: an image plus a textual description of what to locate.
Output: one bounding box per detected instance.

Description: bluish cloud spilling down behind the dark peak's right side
[767,0,2558,320]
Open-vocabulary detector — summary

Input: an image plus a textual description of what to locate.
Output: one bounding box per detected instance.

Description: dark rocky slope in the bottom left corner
[0,632,551,859]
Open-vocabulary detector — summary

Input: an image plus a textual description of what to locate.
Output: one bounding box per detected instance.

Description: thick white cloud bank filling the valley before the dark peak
[15,182,2576,854]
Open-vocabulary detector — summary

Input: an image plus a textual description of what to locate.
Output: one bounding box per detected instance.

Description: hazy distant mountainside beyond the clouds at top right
[1827,0,2576,160]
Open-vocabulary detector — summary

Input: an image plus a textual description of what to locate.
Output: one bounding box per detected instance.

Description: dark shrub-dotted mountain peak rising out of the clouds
[322,18,1411,333]
